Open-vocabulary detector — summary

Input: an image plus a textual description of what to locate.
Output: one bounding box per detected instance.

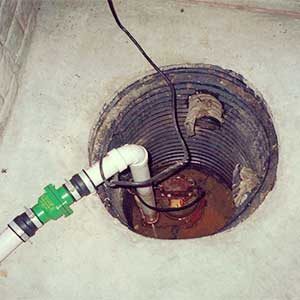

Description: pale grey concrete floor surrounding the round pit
[0,0,300,300]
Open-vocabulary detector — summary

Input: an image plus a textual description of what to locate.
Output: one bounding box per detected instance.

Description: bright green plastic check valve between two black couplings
[32,184,74,224]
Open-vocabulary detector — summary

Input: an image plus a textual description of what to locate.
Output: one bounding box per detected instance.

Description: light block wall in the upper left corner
[0,0,40,139]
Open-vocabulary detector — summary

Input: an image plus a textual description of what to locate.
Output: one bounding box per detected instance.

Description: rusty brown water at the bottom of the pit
[132,169,235,239]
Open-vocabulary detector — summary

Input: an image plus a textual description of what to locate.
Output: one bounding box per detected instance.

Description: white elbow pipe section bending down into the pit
[85,145,157,223]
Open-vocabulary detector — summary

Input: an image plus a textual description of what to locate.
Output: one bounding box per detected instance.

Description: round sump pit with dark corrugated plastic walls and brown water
[89,64,278,239]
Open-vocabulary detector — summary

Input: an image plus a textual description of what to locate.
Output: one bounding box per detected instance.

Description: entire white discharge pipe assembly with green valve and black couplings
[0,145,157,262]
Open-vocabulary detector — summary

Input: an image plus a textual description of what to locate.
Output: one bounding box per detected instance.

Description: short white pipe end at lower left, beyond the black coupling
[0,227,23,262]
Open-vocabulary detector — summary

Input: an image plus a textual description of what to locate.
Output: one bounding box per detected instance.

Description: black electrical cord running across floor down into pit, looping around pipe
[99,0,190,188]
